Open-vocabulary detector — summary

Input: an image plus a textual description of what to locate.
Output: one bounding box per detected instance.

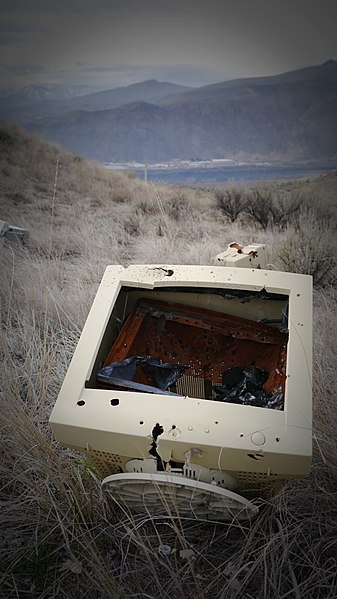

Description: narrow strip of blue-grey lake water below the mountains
[119,163,337,186]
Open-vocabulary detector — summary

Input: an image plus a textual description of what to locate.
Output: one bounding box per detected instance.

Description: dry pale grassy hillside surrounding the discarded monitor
[0,124,337,599]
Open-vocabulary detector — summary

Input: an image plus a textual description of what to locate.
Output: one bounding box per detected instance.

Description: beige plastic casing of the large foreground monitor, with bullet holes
[50,264,312,502]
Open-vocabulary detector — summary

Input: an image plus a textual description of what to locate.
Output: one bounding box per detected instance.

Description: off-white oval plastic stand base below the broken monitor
[102,472,259,521]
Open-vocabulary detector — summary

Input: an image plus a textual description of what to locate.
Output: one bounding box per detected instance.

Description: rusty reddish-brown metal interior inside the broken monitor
[104,298,288,397]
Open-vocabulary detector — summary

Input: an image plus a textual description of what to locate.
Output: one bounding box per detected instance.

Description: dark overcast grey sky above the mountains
[0,0,337,89]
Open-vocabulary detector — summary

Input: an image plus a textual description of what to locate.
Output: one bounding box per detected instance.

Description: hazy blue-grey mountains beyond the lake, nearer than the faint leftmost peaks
[0,60,337,163]
